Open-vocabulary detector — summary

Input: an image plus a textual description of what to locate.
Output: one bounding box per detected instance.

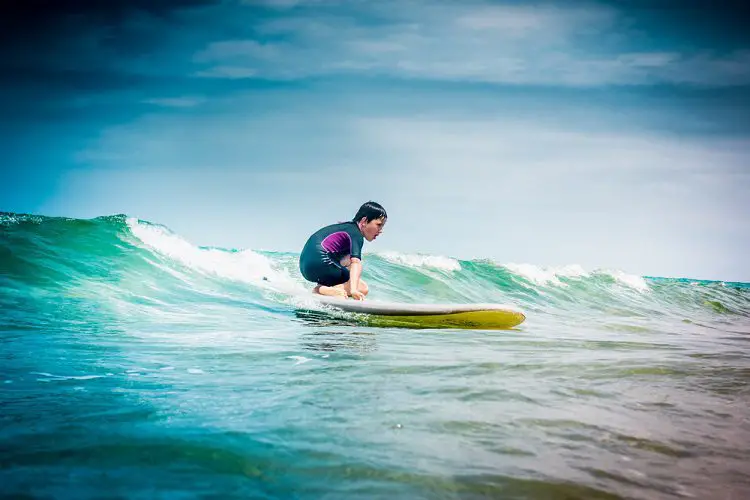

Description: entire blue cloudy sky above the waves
[0,0,750,281]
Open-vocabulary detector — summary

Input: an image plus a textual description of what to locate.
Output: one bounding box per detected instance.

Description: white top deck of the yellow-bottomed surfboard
[310,295,523,316]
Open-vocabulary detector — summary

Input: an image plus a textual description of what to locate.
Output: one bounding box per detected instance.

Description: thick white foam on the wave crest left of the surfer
[127,218,302,292]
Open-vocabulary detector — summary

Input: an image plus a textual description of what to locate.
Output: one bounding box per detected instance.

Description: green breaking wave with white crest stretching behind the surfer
[0,213,750,319]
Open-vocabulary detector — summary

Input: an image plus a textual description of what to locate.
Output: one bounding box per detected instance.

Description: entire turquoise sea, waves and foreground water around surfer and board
[0,213,750,500]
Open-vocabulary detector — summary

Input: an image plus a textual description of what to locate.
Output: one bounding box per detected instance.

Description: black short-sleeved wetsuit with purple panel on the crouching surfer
[299,221,364,286]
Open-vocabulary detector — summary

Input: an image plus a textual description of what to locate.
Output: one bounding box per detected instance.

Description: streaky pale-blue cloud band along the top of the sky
[189,1,750,87]
